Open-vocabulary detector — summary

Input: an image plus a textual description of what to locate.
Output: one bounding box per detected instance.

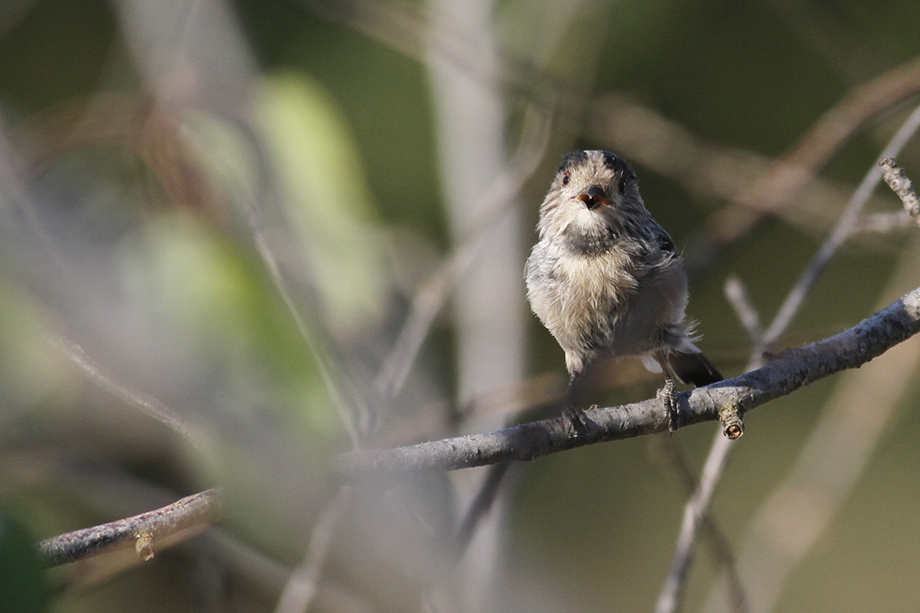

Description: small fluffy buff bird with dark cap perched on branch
[524,151,722,436]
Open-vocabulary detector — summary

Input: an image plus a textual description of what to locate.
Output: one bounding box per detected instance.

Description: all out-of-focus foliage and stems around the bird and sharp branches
[0,0,920,612]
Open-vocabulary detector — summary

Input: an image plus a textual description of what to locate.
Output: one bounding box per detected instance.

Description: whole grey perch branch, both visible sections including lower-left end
[43,288,920,566]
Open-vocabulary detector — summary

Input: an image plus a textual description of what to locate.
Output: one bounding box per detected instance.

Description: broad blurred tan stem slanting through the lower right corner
[704,238,920,612]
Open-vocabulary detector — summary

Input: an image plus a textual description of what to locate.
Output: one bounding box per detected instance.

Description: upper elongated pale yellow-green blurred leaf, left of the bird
[258,72,385,331]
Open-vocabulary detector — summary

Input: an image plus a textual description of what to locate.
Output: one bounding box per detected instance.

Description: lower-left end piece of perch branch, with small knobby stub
[36,489,218,566]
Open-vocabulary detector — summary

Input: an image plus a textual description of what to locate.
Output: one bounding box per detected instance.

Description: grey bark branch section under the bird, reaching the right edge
[338,288,920,479]
